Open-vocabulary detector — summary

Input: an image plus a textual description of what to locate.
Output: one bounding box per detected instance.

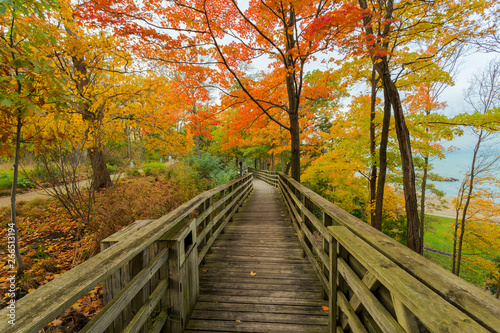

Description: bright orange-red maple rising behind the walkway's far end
[77,0,360,180]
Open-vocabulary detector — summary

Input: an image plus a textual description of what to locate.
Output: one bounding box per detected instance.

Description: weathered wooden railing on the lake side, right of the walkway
[253,171,500,333]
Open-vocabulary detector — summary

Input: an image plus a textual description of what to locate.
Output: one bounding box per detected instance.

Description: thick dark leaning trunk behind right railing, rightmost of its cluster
[376,63,423,254]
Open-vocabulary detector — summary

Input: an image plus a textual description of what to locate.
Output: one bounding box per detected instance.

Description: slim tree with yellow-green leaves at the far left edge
[0,1,63,275]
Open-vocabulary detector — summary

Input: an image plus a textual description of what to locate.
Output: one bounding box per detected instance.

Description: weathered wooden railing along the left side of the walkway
[0,174,253,333]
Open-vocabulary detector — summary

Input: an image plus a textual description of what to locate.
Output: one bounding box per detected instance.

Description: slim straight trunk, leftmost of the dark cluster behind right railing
[370,68,380,230]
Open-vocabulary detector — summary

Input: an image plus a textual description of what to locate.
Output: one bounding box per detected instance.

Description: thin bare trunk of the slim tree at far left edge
[10,114,24,276]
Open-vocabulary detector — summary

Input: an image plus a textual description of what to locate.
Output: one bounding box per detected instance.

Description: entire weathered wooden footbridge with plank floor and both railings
[0,170,500,333]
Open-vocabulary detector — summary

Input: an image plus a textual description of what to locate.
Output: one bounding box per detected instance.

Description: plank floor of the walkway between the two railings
[185,180,328,333]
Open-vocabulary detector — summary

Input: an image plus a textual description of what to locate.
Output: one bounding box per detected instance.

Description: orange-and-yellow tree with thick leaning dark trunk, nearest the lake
[310,0,490,253]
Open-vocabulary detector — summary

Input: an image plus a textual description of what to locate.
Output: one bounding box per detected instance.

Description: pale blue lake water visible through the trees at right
[430,149,500,197]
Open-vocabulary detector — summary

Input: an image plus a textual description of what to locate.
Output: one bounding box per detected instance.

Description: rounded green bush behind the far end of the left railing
[186,153,238,188]
